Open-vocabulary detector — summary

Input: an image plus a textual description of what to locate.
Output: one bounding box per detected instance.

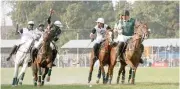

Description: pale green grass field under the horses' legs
[1,68,179,89]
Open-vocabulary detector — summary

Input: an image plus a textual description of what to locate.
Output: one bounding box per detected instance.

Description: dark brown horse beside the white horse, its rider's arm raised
[32,25,53,86]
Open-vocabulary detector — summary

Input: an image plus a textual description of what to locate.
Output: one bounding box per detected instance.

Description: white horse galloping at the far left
[12,39,35,86]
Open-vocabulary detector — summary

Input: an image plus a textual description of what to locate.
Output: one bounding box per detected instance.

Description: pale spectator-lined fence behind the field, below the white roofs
[1,49,179,67]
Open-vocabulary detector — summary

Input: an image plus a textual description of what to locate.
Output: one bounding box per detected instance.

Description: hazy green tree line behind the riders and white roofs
[1,1,180,50]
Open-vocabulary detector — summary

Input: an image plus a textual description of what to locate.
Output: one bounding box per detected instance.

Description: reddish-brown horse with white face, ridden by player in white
[88,30,112,84]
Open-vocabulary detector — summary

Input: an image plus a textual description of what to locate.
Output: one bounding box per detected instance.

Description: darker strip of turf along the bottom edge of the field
[1,83,178,89]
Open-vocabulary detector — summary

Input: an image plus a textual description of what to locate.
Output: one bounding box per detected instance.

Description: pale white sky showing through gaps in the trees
[1,0,135,26]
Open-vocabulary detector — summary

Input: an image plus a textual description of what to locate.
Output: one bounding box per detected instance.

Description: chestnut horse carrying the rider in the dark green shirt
[117,22,149,84]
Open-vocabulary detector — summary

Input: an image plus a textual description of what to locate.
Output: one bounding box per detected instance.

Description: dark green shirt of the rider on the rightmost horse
[121,18,135,36]
